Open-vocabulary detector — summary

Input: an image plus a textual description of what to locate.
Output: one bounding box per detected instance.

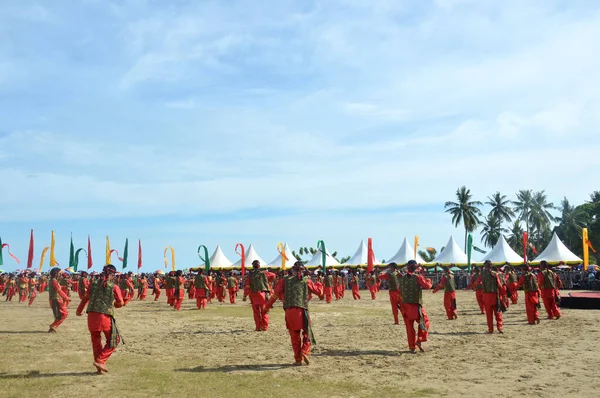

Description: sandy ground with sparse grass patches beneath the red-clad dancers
[0,291,600,397]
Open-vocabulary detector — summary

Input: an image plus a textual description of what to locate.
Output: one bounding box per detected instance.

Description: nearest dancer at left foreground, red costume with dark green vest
[76,264,125,374]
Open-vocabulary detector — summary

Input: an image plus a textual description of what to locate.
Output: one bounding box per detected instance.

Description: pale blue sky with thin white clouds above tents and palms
[0,0,600,270]
